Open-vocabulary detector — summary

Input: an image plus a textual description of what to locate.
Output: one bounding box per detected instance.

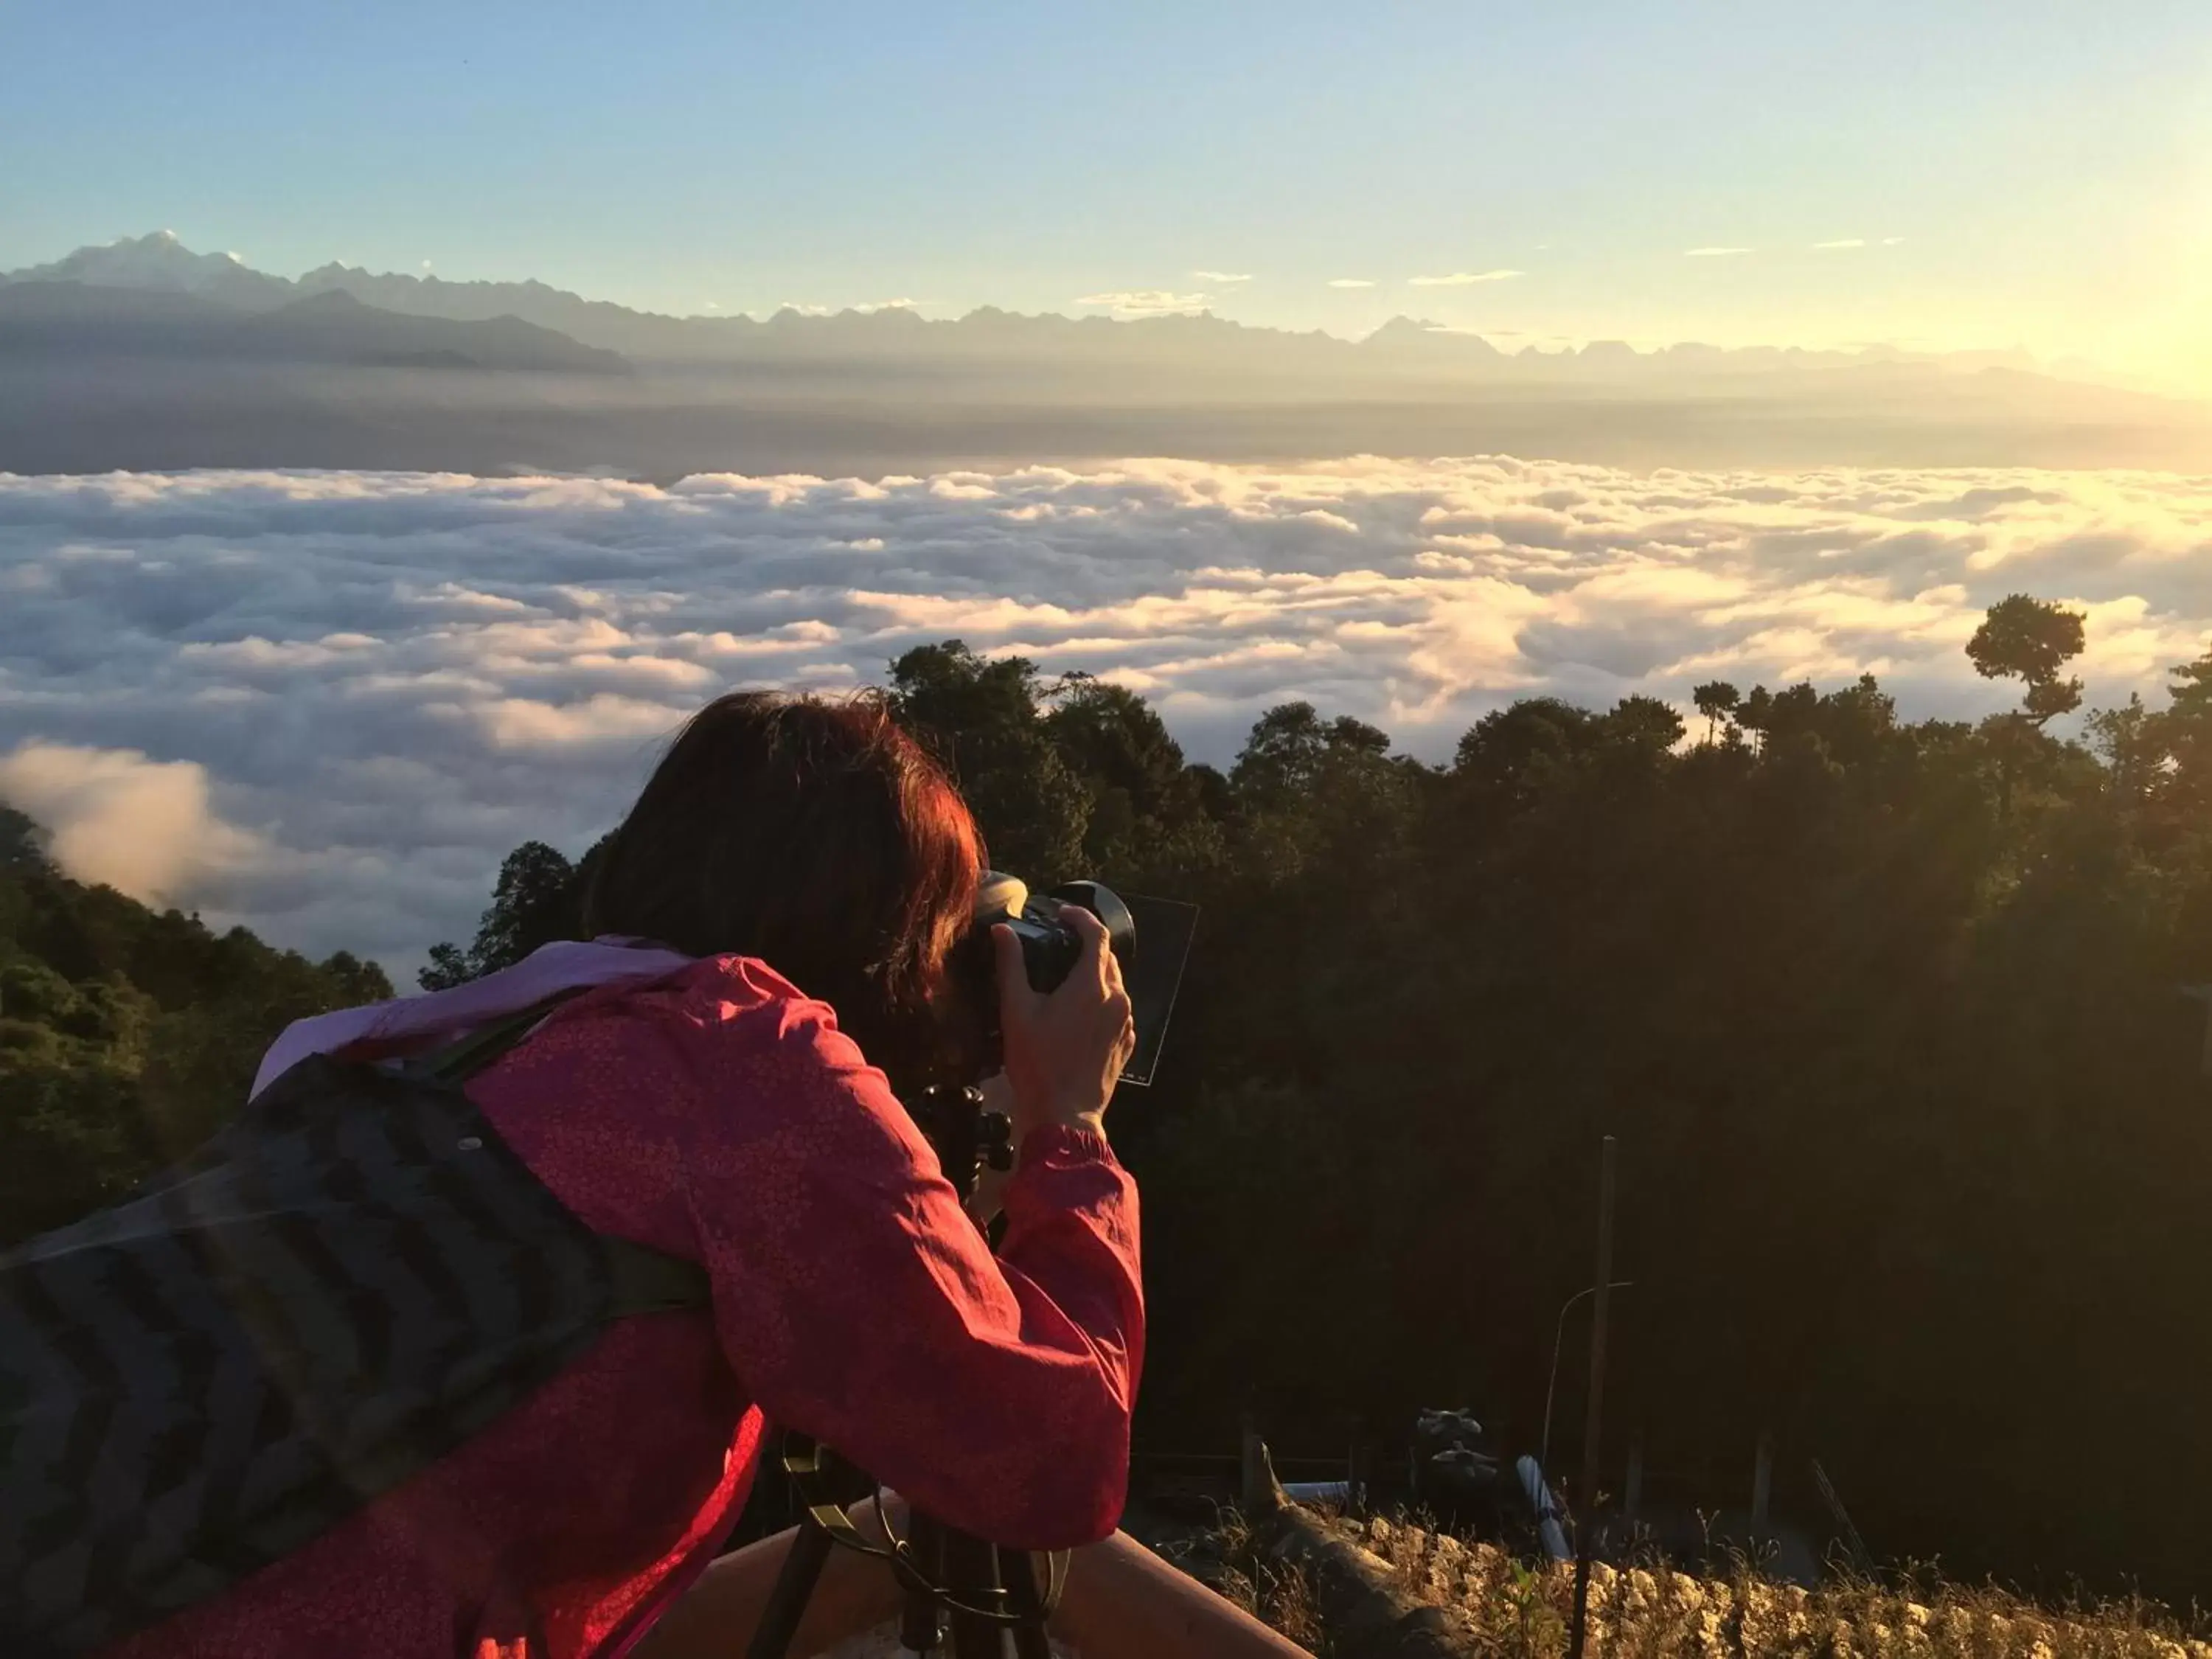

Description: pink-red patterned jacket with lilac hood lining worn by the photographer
[115,945,1144,1659]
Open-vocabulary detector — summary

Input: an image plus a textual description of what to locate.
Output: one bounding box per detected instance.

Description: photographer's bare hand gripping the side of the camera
[991,905,1137,1146]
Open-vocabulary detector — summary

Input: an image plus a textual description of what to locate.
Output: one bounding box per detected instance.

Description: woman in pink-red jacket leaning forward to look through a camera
[113,692,1144,1659]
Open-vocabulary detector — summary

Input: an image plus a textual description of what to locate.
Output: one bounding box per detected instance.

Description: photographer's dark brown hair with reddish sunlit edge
[584,692,982,1082]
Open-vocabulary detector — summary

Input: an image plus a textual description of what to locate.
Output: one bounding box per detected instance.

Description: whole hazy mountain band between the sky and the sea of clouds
[0,232,2212,478]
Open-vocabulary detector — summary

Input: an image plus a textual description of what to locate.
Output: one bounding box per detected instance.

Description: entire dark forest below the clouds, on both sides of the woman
[0,595,2212,1595]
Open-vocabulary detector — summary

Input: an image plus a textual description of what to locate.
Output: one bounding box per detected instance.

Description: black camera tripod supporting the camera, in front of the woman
[745,1086,1066,1659]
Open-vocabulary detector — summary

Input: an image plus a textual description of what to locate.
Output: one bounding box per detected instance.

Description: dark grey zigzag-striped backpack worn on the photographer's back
[0,1004,706,1659]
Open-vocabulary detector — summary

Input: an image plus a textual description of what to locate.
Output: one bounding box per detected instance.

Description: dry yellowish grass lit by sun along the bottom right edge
[1179,1515,2212,1659]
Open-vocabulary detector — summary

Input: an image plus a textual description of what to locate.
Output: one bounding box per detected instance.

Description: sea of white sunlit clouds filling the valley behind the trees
[0,458,2212,978]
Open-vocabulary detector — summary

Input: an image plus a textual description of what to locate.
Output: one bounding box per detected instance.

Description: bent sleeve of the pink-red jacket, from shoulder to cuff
[686,1002,1144,1548]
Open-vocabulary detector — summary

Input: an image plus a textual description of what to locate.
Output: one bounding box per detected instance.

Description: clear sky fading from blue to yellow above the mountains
[13,0,2212,389]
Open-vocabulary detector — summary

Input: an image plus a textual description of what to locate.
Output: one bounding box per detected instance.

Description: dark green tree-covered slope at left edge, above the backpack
[0,832,392,1243]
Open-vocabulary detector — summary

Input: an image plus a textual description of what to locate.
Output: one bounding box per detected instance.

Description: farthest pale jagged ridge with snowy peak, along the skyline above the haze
[0,230,2042,380]
